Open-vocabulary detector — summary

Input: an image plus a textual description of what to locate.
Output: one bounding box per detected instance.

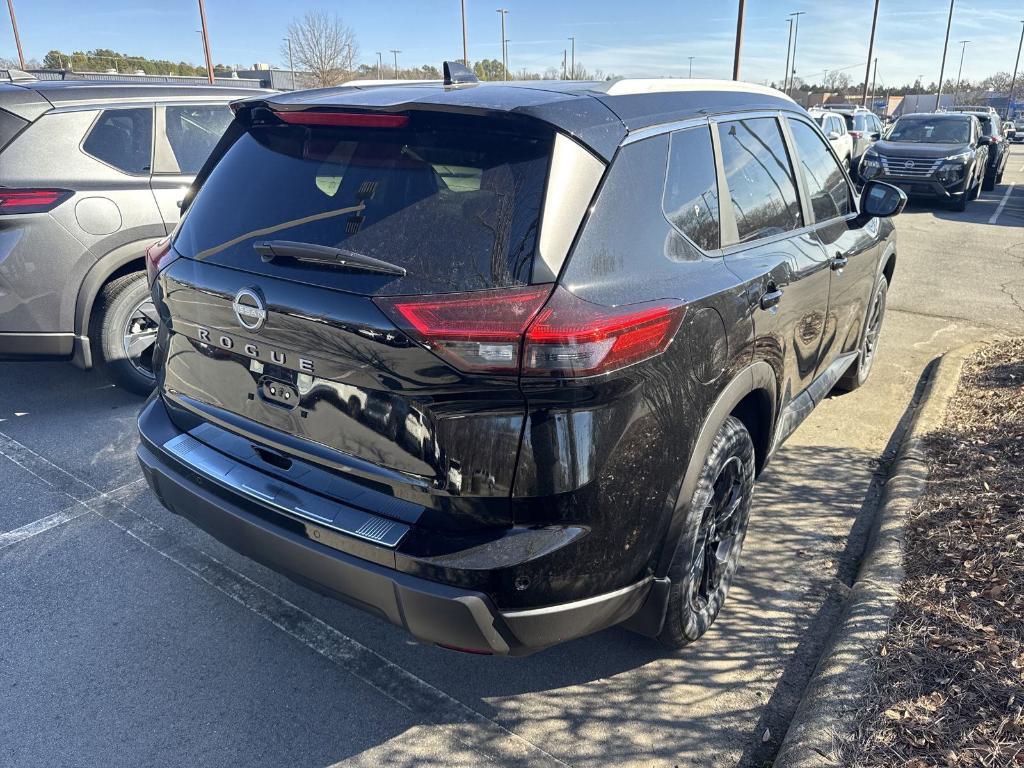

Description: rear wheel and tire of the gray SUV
[89,272,158,396]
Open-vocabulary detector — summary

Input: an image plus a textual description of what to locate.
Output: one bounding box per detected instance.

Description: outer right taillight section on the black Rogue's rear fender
[522,286,685,376]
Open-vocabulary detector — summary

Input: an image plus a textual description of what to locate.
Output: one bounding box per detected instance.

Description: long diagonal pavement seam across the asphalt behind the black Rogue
[0,432,567,766]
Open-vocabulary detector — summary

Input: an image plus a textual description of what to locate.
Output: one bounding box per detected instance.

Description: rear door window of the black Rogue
[718,118,803,243]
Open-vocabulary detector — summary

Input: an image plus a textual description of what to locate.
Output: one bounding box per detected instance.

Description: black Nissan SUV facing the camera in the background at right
[860,113,989,211]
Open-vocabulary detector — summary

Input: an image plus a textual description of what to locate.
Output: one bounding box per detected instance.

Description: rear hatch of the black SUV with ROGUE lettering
[157,108,554,527]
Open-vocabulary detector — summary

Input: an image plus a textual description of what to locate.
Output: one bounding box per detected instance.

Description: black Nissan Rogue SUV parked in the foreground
[138,67,905,654]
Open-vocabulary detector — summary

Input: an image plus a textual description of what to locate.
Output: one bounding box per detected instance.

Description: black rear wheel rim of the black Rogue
[689,456,743,611]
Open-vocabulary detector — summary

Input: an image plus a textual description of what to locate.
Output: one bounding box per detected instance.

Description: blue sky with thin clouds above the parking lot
[8,0,1024,85]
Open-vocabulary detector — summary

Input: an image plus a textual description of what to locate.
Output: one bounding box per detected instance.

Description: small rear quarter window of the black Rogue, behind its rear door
[662,126,721,251]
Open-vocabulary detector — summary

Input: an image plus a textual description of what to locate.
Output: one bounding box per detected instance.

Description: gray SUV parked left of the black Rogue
[0,79,264,394]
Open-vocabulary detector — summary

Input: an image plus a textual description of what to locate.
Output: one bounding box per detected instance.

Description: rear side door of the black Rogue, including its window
[716,114,829,406]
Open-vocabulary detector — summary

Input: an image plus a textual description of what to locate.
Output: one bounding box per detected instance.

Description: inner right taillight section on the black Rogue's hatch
[374,286,551,374]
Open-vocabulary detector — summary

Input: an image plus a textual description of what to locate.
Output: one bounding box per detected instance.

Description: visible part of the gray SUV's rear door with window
[151,102,232,231]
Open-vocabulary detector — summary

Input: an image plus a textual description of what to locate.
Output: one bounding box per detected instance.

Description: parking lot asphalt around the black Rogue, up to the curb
[6,145,1024,766]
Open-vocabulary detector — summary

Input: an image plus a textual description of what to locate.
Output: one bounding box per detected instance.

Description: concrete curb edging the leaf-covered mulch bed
[773,343,983,768]
